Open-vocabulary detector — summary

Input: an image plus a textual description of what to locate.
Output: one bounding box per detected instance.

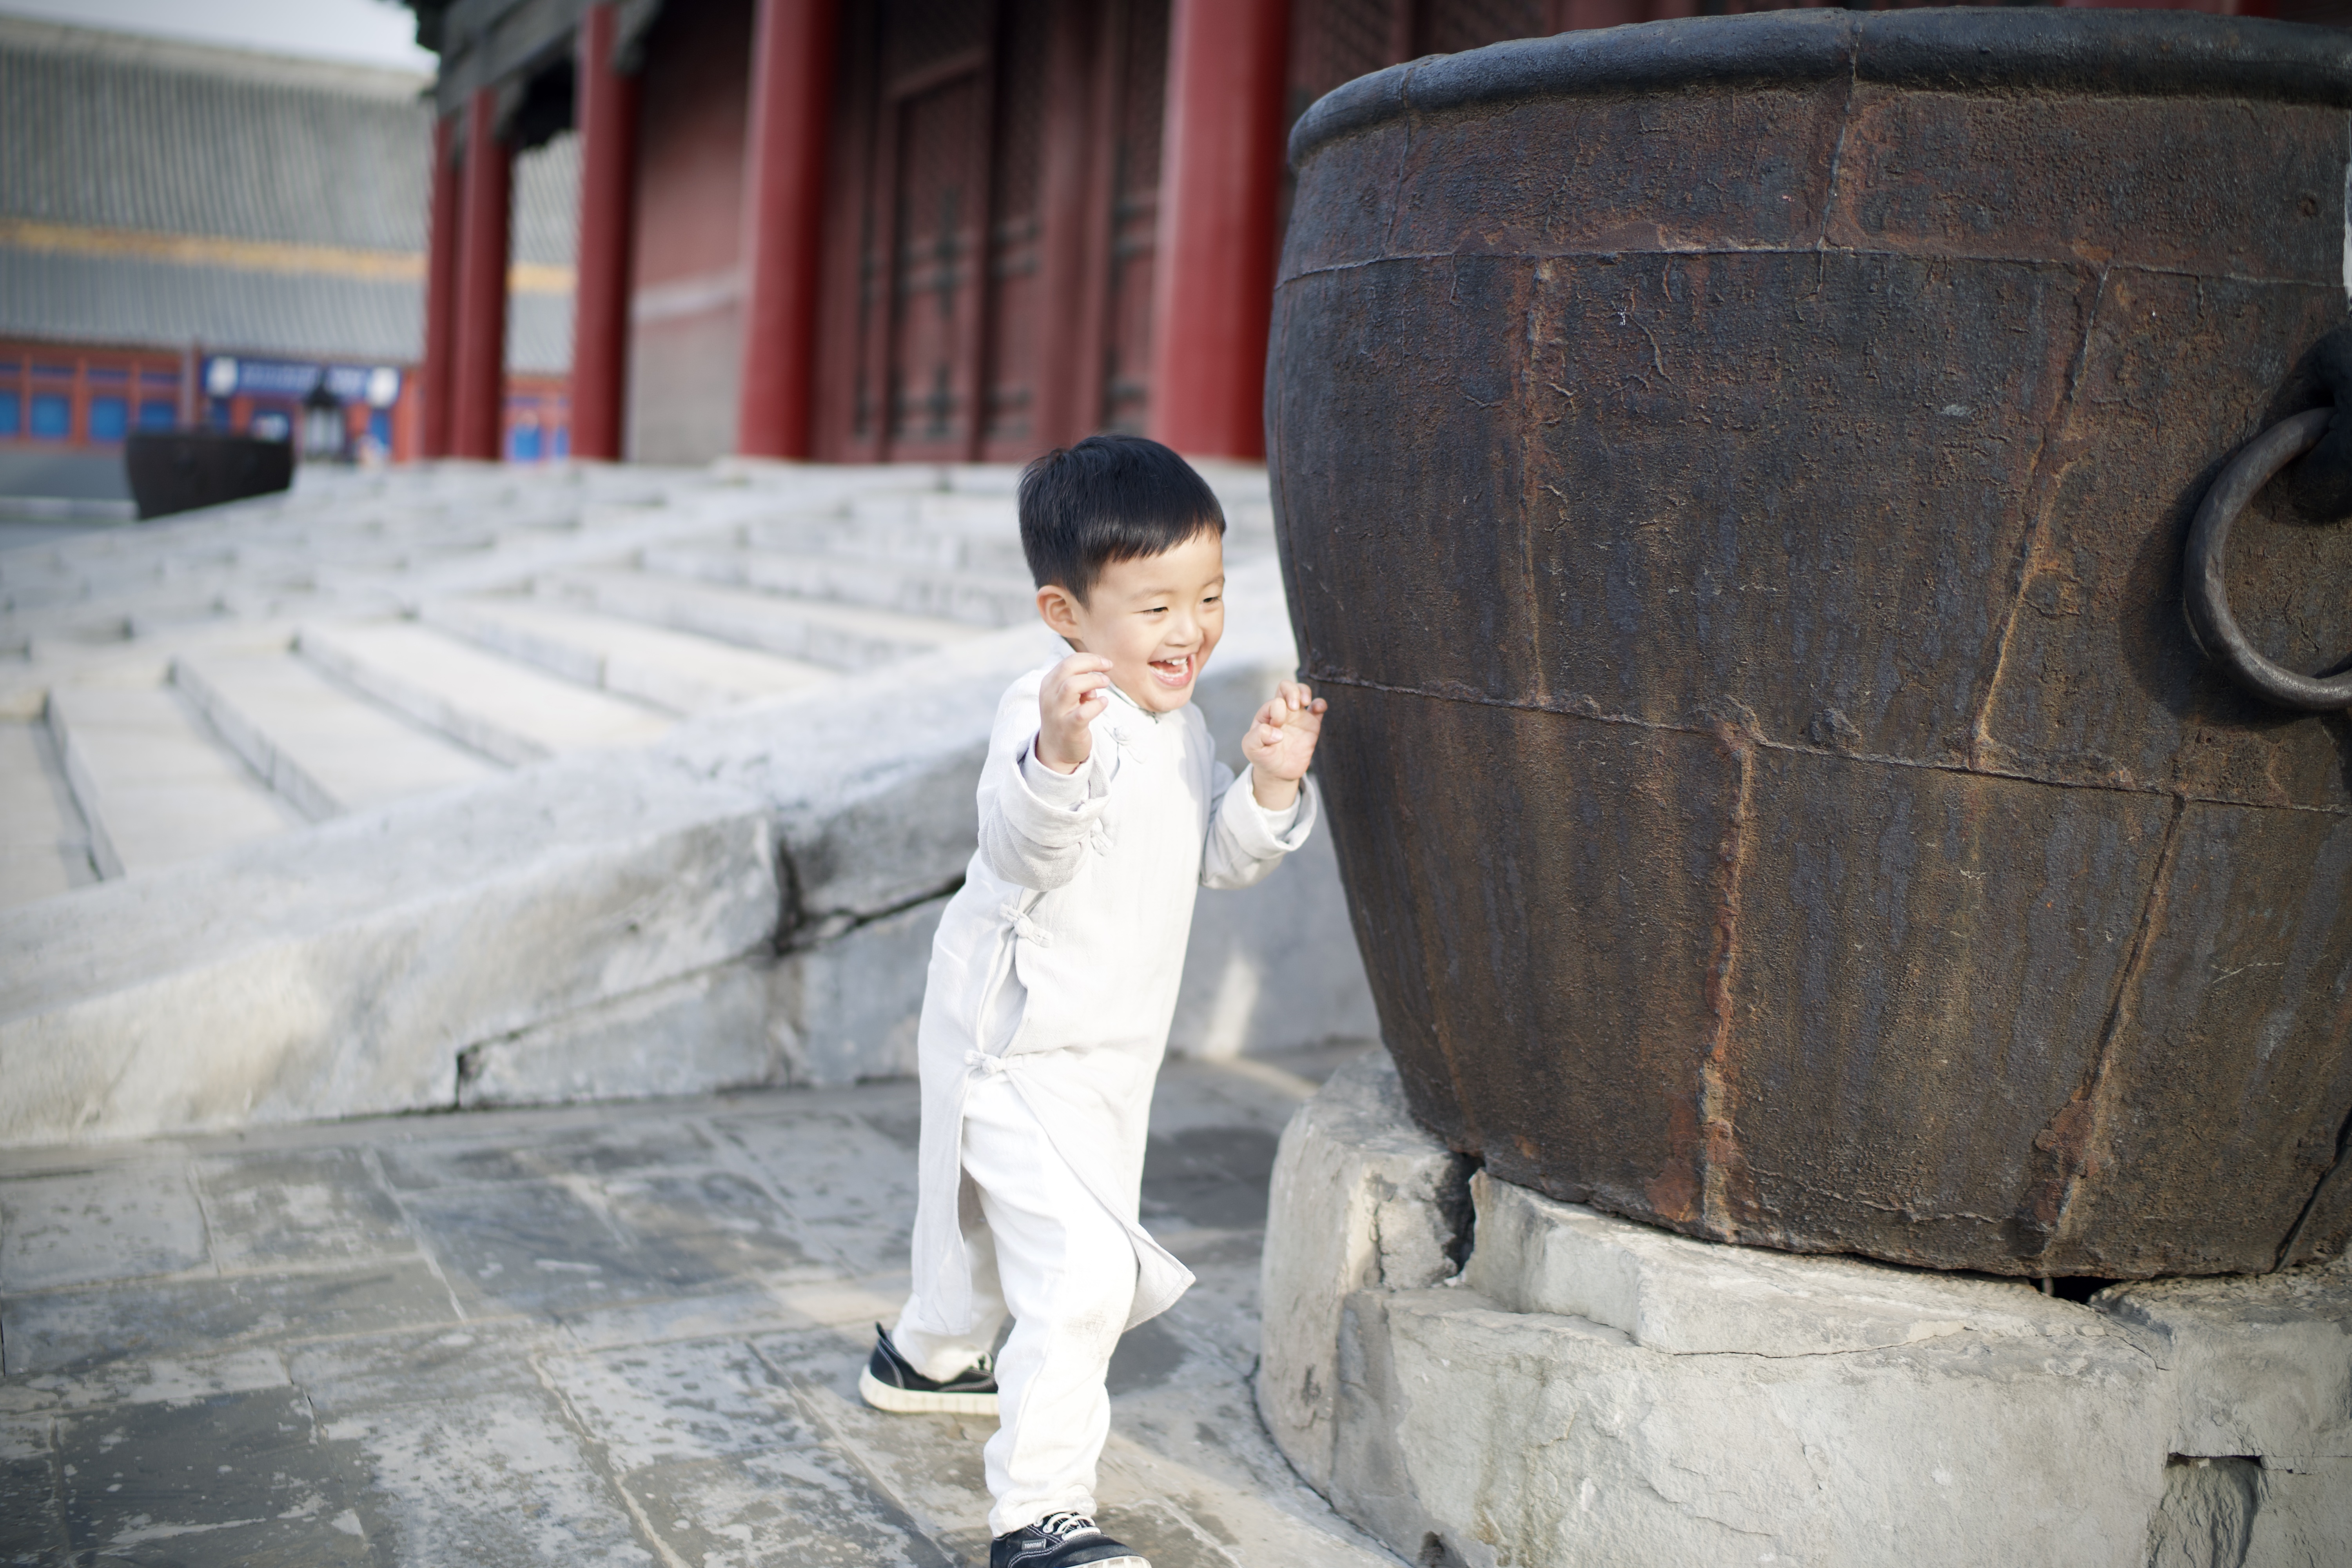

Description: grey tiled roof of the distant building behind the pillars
[0,19,579,374]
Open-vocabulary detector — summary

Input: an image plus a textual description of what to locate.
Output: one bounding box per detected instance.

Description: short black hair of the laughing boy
[1021,435,1225,604]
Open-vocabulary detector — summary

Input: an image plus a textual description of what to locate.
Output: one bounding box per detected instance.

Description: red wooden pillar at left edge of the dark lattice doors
[736,0,840,458]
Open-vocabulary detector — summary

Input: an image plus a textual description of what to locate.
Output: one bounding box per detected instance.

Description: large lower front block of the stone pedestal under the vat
[1374,1290,2164,1568]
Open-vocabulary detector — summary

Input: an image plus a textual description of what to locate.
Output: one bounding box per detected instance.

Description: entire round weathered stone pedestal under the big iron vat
[1258,1058,2352,1568]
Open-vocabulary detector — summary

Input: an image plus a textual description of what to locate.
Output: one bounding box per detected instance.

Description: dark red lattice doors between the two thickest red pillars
[816,0,1169,461]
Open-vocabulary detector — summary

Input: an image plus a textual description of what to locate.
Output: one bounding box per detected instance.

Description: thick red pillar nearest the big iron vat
[1150,0,1291,458]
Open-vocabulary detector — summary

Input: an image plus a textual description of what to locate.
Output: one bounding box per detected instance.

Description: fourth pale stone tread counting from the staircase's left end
[294,621,673,766]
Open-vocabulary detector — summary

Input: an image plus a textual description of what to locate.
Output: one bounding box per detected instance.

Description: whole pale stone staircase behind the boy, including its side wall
[0,463,1376,1147]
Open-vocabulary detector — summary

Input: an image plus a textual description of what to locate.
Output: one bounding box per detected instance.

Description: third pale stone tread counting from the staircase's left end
[172,649,499,818]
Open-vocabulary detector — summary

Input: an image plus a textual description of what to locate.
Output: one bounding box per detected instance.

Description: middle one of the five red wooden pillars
[572,0,637,461]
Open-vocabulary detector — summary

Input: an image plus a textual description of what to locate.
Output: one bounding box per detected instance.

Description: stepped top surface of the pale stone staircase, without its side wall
[0,465,1272,907]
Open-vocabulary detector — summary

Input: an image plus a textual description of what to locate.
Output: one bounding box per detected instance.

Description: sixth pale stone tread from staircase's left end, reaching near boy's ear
[541,566,985,670]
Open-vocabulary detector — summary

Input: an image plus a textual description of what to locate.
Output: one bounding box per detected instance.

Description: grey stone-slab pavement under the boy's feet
[0,1049,1397,1568]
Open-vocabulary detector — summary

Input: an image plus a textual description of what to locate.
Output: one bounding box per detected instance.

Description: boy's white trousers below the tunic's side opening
[891,1072,1136,1535]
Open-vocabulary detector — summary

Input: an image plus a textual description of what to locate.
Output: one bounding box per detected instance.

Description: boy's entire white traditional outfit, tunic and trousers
[891,661,1317,1535]
